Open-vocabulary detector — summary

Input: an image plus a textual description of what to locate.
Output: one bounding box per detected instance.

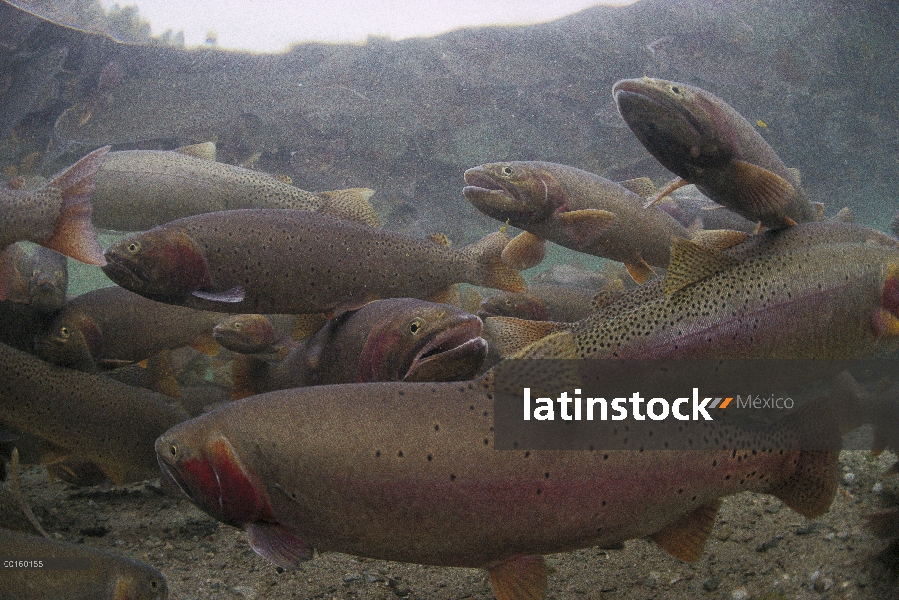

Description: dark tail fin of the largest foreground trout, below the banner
[768,398,842,519]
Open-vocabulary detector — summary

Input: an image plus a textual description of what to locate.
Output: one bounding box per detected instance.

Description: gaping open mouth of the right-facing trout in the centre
[402,315,487,381]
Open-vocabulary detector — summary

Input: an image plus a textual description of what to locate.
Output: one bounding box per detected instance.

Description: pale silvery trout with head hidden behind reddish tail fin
[92,142,380,231]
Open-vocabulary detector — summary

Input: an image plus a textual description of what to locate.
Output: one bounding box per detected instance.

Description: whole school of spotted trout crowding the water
[0,74,899,600]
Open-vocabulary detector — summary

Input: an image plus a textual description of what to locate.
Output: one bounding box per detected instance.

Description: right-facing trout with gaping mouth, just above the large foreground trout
[233,298,487,399]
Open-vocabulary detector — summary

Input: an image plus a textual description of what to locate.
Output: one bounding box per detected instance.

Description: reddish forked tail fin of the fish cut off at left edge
[37,146,110,267]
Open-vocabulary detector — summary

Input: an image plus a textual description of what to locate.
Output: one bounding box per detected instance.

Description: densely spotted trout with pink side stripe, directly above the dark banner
[484,221,899,358]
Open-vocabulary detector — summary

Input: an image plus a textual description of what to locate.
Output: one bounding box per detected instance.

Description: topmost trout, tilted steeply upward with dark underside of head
[612,77,823,229]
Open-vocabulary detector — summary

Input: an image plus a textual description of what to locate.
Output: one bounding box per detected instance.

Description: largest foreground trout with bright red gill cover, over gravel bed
[156,374,839,600]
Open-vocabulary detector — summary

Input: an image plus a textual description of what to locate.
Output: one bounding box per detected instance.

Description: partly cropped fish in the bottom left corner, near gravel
[0,529,169,600]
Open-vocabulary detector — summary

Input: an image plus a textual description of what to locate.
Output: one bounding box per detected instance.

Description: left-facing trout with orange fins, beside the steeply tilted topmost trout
[462,162,690,283]
